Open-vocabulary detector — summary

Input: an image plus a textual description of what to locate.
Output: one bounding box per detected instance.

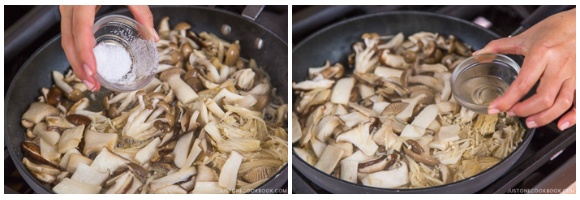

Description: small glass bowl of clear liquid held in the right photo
[451,54,520,114]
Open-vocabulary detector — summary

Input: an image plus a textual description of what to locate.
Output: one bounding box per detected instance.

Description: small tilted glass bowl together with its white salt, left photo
[93,15,159,92]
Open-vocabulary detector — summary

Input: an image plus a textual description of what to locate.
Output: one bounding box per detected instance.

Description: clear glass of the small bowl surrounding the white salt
[93,15,159,92]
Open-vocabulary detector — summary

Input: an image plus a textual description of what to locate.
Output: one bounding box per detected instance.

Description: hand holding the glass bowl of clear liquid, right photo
[474,9,576,130]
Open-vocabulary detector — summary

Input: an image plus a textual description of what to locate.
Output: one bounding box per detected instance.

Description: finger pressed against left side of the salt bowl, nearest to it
[72,6,100,91]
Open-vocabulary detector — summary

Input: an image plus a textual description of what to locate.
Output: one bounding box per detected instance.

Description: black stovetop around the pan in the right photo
[292,5,576,193]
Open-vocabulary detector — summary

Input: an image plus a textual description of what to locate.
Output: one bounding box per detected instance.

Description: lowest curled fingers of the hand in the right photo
[526,79,576,128]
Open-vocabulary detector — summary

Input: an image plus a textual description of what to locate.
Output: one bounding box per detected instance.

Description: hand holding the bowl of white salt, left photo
[60,6,159,92]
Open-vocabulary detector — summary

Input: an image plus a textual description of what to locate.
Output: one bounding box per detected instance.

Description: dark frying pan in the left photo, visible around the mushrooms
[4,6,288,193]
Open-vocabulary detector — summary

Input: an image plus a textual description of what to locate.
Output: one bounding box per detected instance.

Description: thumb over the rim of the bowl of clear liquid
[473,36,525,55]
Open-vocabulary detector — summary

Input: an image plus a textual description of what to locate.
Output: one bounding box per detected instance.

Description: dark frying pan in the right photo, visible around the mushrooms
[292,12,535,193]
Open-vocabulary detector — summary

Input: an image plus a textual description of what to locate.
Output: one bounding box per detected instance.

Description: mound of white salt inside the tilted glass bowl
[93,42,135,85]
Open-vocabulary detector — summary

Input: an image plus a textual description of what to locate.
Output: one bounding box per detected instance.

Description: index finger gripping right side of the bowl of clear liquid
[488,48,547,114]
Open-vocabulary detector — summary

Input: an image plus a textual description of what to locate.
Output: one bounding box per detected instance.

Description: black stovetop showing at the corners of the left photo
[4,5,288,194]
